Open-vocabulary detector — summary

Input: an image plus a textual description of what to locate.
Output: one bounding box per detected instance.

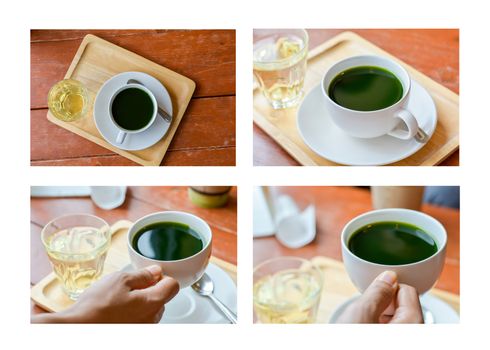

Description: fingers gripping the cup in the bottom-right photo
[337,271,424,323]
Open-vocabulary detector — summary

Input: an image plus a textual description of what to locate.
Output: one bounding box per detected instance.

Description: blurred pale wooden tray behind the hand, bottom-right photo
[312,256,459,323]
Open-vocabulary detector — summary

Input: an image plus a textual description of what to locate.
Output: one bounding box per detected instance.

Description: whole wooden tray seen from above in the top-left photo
[47,34,196,165]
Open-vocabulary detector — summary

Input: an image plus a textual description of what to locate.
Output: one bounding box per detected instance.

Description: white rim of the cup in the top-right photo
[321,55,412,115]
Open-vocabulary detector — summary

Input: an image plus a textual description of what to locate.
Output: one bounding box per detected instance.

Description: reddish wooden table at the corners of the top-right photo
[254,29,459,166]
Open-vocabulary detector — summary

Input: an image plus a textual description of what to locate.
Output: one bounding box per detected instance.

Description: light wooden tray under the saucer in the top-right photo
[254,32,459,165]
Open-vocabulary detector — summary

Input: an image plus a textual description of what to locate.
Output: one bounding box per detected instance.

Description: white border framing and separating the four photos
[0,0,490,350]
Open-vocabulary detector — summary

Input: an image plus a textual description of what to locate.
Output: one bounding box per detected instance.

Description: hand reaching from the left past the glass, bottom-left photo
[32,265,179,323]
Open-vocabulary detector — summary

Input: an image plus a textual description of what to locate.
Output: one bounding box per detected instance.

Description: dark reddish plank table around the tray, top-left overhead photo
[31,30,235,165]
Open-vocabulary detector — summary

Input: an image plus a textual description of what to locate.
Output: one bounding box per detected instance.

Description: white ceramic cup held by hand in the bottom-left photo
[128,211,212,288]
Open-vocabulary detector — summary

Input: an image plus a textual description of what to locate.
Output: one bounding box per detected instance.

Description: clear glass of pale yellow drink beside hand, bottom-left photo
[41,214,111,300]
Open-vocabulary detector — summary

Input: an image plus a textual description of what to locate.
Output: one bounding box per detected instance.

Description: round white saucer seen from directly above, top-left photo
[94,72,172,151]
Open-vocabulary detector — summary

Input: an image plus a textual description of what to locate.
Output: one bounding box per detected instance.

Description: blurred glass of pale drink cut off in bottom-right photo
[253,257,323,323]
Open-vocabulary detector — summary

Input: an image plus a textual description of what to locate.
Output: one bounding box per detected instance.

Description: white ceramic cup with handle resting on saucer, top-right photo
[322,56,425,142]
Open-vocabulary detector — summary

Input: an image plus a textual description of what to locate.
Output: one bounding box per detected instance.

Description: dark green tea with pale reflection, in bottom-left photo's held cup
[132,222,204,261]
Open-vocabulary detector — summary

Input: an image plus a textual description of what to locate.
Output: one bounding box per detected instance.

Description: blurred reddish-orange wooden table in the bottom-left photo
[31,187,237,313]
